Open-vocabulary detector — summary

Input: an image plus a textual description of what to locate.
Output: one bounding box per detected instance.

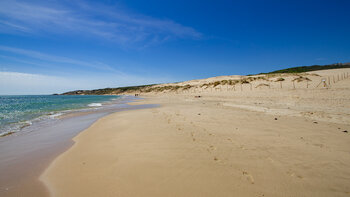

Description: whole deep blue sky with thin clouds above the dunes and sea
[0,0,350,95]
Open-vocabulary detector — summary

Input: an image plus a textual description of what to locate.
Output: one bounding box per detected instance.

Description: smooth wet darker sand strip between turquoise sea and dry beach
[0,99,156,197]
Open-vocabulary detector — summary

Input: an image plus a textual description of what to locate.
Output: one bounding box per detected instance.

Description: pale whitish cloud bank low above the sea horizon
[0,72,169,95]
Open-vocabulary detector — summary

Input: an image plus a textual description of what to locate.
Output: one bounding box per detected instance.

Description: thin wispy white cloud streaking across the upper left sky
[0,0,202,46]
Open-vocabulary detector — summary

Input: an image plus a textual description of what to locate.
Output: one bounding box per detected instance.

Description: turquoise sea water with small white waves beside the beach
[0,95,119,135]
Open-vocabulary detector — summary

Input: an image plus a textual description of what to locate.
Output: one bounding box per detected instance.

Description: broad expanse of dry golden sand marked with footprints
[41,69,350,197]
